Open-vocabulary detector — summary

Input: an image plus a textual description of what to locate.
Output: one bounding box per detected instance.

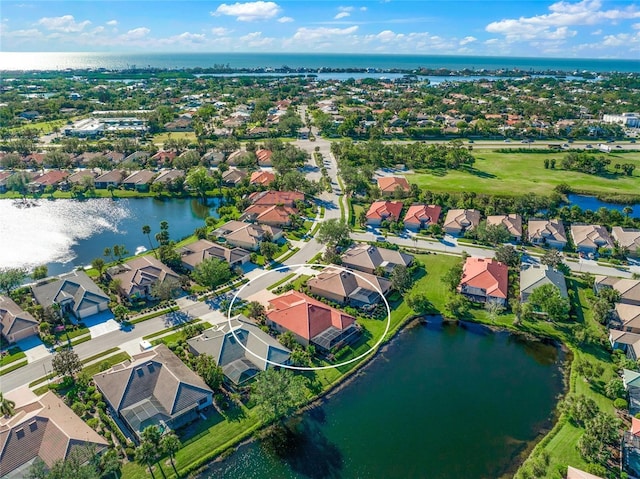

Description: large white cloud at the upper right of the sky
[485,0,640,42]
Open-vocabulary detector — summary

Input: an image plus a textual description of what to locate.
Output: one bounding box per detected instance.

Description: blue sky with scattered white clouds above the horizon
[0,0,640,59]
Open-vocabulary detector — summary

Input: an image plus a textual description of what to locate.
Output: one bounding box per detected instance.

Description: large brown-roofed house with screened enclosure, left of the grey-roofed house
[93,344,213,438]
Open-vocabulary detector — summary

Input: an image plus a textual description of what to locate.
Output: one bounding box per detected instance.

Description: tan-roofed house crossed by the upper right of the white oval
[307,267,391,307]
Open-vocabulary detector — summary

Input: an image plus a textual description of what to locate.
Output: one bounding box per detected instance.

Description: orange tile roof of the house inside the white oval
[267,291,355,340]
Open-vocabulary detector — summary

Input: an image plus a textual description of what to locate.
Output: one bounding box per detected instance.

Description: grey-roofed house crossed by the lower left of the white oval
[187,314,291,386]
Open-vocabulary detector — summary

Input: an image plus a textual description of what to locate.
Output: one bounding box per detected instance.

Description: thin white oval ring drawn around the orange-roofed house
[227,263,391,371]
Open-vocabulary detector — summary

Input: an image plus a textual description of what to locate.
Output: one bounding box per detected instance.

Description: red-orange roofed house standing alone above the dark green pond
[457,258,509,306]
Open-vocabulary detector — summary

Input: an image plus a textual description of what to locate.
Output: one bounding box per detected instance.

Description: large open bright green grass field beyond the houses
[407,150,640,195]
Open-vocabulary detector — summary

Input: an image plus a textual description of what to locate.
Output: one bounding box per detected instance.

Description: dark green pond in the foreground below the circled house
[199,325,562,479]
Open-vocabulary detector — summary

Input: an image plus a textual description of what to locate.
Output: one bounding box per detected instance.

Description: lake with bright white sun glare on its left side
[0,198,217,274]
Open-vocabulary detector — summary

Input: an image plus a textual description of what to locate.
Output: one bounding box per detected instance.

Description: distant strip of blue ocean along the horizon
[0,52,640,73]
